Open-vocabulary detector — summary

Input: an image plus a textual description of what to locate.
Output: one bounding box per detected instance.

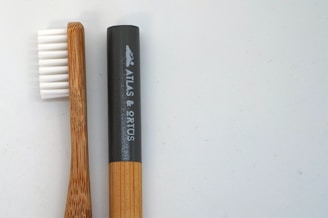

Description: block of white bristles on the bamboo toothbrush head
[38,26,69,99]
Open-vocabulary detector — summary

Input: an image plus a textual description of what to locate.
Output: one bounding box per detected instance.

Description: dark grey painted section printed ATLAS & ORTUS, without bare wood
[107,25,141,162]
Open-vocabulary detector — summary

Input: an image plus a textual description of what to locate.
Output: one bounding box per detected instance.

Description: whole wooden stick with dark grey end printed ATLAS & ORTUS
[107,25,142,218]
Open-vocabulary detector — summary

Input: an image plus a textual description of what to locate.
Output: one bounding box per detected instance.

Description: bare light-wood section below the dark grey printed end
[109,162,142,218]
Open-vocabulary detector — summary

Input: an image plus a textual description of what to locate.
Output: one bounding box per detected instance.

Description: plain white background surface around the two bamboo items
[0,0,328,218]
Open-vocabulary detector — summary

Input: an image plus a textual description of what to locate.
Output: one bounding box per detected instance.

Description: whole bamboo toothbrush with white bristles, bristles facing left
[38,22,92,218]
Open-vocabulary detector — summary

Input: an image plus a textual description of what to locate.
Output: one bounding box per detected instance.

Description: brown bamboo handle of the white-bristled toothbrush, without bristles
[65,23,92,218]
